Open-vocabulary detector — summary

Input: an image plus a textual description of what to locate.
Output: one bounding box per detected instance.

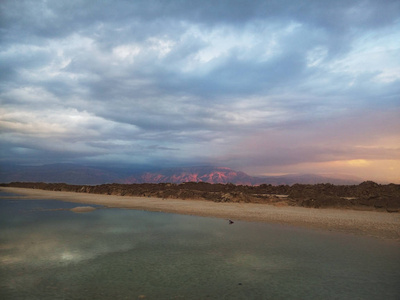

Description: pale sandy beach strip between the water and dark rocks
[0,187,400,242]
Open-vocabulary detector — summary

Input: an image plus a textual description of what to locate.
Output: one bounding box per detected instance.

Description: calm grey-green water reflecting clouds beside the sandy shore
[0,194,400,299]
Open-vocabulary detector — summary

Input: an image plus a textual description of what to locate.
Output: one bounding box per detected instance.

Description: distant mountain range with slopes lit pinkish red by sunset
[0,164,363,185]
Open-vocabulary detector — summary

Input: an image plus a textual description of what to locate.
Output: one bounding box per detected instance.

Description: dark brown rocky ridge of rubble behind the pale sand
[0,181,400,213]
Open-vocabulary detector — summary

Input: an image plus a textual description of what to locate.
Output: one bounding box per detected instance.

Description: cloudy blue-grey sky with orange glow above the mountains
[0,0,400,183]
